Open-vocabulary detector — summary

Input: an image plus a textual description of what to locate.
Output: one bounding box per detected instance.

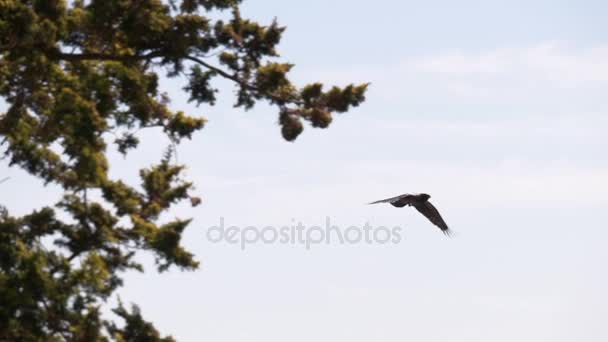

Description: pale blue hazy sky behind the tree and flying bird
[0,0,608,342]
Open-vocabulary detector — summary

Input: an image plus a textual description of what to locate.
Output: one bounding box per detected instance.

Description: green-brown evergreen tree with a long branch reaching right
[0,0,367,341]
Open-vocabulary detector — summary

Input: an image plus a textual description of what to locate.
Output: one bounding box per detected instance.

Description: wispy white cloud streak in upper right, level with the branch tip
[294,42,608,103]
